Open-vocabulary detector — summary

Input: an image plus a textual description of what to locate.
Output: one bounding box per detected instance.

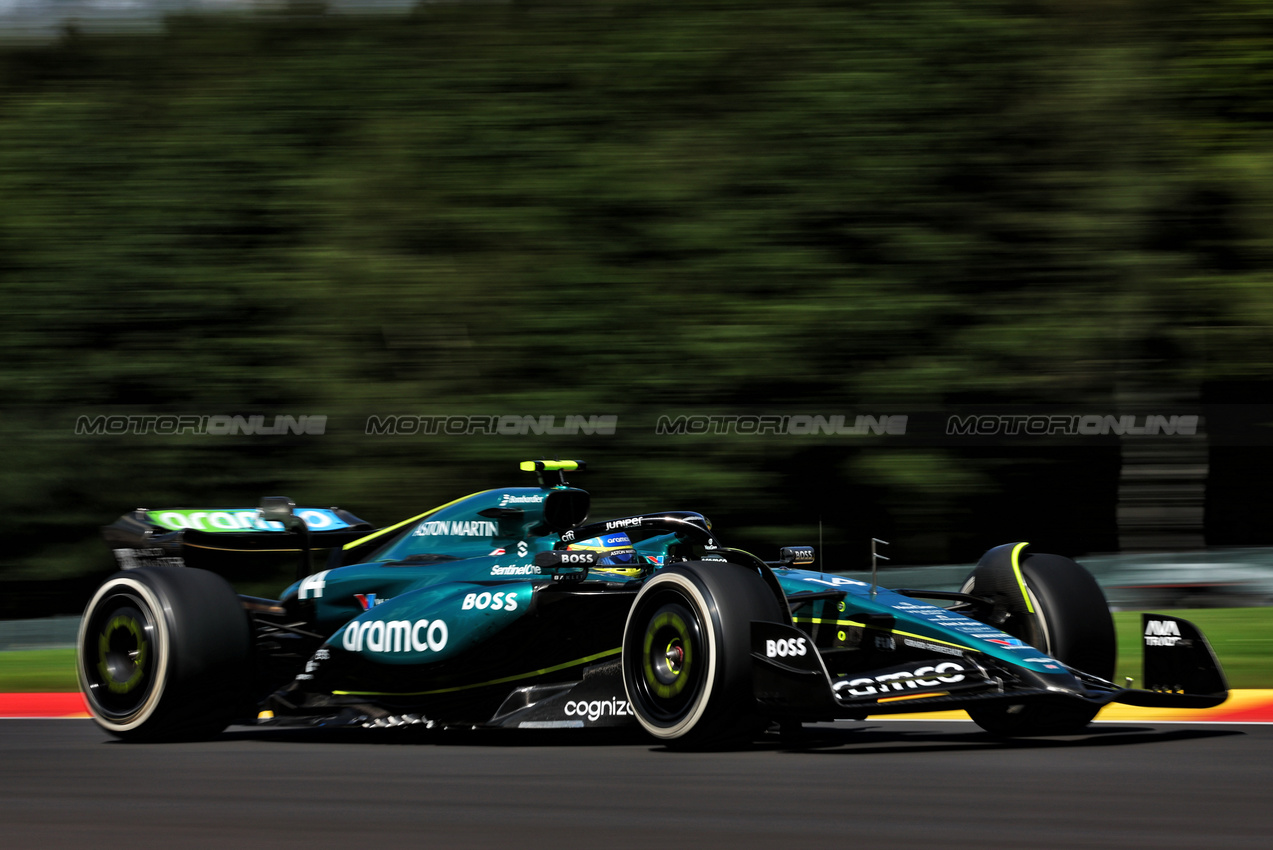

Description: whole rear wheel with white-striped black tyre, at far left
[76,568,252,741]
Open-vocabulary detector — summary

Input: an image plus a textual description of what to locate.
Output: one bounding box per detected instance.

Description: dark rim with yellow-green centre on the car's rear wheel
[80,590,159,720]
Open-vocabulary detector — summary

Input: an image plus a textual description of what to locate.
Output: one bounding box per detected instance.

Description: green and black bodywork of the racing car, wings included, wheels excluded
[94,460,1227,728]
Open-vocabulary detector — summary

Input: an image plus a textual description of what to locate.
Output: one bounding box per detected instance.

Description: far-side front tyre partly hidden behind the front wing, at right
[962,555,1118,737]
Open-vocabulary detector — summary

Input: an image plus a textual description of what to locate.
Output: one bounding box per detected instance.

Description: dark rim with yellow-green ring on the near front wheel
[630,590,708,725]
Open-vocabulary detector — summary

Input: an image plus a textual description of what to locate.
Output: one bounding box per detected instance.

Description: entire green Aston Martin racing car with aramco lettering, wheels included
[78,461,1227,747]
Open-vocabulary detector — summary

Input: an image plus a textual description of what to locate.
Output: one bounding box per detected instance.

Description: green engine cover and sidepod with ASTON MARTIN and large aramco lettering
[269,486,710,725]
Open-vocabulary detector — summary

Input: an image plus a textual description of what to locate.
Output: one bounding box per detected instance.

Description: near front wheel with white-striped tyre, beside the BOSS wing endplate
[622,561,783,748]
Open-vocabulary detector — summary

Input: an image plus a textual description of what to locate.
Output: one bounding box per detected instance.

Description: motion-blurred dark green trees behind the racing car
[0,0,1273,617]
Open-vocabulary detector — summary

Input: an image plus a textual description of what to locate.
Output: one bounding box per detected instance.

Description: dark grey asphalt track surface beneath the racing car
[0,720,1273,850]
